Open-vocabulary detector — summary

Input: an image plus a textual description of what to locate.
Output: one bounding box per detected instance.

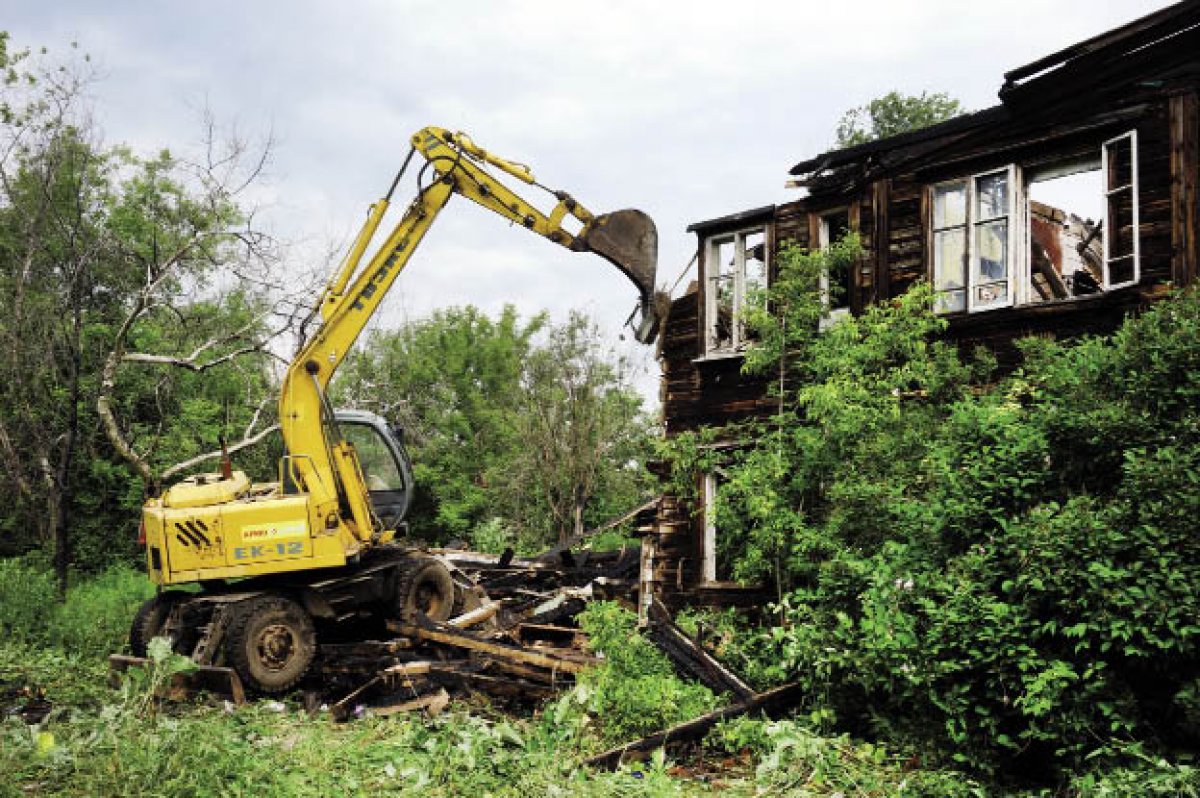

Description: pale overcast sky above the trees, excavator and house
[9,0,1168,398]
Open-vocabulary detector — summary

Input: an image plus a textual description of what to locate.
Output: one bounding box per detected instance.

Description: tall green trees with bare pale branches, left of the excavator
[0,36,283,578]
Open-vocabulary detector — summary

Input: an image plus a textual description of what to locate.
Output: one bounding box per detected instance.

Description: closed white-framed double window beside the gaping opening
[932,167,1014,312]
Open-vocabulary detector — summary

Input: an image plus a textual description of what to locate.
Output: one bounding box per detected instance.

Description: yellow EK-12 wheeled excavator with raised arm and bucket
[130,127,658,694]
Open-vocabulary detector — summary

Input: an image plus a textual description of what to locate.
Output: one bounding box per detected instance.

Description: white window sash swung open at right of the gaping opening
[1104,132,1139,288]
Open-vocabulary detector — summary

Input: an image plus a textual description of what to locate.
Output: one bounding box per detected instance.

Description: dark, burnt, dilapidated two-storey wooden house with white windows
[643,0,1200,604]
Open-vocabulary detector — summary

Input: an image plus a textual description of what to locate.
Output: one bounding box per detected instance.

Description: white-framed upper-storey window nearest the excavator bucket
[704,227,767,353]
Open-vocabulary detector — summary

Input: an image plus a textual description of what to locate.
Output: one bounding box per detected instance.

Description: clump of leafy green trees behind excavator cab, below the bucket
[335,306,649,550]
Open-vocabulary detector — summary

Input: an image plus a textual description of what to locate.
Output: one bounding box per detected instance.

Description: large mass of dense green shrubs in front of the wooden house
[666,258,1200,780]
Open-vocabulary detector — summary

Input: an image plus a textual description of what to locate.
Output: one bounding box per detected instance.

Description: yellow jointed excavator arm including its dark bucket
[280,127,658,547]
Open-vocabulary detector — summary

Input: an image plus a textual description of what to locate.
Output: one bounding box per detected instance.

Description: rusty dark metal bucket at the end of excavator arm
[571,209,659,343]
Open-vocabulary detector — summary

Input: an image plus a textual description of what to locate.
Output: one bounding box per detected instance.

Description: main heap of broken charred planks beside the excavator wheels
[308,542,637,720]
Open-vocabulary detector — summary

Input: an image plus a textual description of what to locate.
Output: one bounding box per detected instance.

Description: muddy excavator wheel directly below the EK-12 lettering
[224,595,317,695]
